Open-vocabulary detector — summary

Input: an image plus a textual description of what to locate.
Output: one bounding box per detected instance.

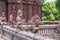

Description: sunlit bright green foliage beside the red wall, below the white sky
[41,0,60,21]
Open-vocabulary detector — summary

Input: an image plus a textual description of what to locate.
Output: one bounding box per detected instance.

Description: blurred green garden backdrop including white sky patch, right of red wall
[41,0,60,21]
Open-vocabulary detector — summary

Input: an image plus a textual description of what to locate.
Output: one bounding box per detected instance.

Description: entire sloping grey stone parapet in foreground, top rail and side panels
[2,25,54,40]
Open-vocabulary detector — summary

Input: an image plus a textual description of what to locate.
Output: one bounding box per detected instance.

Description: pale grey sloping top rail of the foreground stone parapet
[2,25,54,40]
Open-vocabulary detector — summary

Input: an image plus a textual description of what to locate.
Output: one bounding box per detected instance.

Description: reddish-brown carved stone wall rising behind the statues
[0,0,42,22]
